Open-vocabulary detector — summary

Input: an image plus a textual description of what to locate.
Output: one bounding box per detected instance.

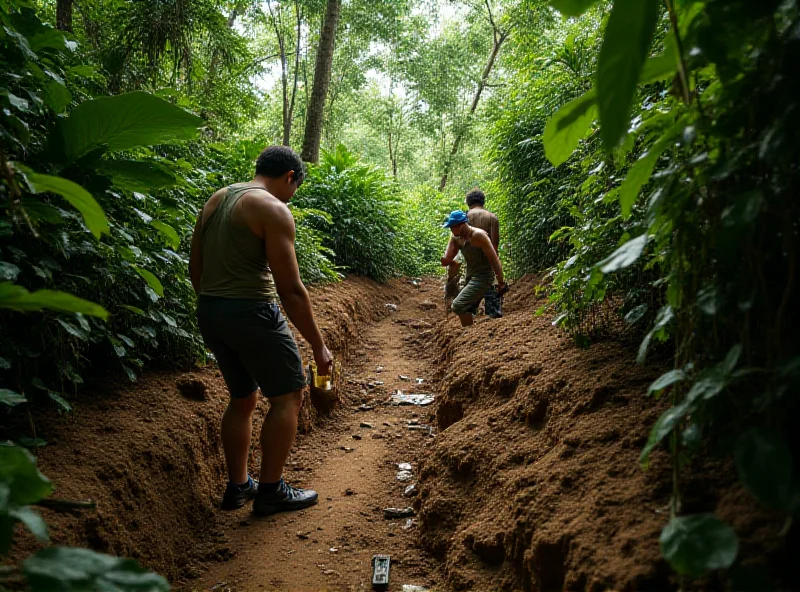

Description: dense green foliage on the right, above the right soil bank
[491,0,800,576]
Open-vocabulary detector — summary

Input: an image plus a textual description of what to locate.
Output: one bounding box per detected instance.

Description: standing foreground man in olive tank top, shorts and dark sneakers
[189,146,332,516]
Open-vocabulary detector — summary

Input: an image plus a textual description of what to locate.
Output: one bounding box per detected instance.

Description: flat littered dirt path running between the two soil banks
[194,285,442,592]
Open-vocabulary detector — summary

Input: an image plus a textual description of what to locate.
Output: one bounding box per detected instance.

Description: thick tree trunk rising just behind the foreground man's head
[302,0,342,163]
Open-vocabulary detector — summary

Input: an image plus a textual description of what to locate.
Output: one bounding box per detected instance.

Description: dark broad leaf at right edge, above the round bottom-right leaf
[736,428,793,511]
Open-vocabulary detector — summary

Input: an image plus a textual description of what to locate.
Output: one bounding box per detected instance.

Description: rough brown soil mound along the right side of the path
[418,278,792,592]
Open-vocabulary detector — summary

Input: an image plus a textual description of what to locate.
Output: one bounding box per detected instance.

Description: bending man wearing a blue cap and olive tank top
[442,210,504,327]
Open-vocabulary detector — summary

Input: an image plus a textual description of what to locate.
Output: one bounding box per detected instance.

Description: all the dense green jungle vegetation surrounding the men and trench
[0,0,800,590]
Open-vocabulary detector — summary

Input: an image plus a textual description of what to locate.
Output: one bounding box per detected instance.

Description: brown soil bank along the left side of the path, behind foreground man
[0,278,396,582]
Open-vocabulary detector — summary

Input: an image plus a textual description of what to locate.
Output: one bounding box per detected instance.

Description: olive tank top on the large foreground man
[200,183,278,301]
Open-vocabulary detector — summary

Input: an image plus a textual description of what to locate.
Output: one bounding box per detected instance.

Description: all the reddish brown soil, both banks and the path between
[7,278,796,592]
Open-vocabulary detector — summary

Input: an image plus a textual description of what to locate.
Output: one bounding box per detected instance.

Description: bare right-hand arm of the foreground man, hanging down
[263,204,329,374]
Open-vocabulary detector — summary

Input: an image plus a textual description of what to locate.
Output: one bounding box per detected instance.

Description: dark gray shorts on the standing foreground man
[197,295,306,398]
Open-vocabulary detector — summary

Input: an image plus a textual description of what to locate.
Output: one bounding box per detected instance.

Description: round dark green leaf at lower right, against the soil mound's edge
[660,514,739,577]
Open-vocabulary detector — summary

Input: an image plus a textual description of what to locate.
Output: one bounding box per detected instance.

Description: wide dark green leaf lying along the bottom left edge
[23,547,169,592]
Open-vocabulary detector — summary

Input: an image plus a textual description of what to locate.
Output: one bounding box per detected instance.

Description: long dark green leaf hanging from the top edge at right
[597,0,660,150]
